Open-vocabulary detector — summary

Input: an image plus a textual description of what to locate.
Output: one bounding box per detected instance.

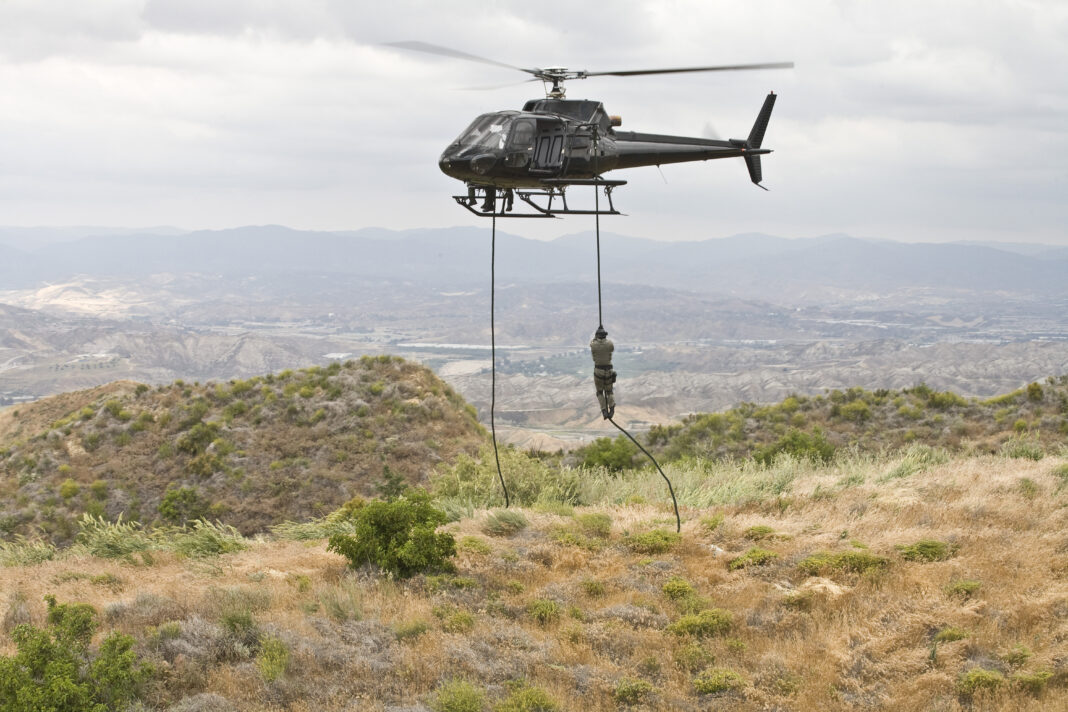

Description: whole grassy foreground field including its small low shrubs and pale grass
[0,447,1068,712]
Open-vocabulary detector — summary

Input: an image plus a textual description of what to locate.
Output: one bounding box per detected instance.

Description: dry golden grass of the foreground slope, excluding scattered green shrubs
[0,457,1068,712]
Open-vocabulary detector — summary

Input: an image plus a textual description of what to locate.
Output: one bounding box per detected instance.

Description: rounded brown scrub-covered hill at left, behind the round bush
[0,357,485,542]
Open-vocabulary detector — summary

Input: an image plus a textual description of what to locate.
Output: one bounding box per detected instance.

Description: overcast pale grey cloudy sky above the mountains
[0,0,1068,244]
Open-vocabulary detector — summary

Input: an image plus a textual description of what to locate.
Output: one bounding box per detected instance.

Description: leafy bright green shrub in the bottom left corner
[0,596,152,712]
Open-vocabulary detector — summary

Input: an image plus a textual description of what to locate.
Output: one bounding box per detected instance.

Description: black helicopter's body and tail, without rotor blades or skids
[438,94,774,188]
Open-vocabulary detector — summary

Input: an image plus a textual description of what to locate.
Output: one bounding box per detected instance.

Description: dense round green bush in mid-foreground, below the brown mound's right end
[328,490,456,577]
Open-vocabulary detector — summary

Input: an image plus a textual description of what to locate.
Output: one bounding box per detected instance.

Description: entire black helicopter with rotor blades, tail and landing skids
[387,42,794,218]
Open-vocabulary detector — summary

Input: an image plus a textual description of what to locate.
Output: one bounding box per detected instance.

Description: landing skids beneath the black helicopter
[453,178,627,218]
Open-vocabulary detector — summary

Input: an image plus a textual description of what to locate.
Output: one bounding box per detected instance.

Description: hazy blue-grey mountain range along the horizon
[3,225,1068,299]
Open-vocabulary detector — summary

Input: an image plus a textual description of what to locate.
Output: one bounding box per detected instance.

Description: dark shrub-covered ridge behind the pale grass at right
[567,376,1068,468]
